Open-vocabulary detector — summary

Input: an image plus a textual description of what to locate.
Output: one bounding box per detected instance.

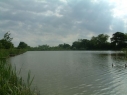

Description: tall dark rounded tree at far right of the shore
[110,32,127,50]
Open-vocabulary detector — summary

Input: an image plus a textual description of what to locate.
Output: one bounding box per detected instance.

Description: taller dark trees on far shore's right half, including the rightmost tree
[71,32,127,50]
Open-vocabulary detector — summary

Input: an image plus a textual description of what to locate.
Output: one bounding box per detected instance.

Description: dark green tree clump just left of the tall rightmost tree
[72,34,109,50]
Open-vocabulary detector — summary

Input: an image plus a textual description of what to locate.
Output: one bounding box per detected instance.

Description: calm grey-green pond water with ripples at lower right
[10,51,127,95]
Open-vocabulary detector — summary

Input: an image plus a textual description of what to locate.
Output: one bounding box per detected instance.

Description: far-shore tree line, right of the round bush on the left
[30,32,127,51]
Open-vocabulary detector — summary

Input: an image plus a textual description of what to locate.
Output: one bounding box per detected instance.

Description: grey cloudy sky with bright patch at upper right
[0,0,127,46]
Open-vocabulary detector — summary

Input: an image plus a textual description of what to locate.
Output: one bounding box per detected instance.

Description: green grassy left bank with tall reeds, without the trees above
[0,50,39,95]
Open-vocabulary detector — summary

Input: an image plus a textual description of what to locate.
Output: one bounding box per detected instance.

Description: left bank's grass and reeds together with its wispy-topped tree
[0,32,39,95]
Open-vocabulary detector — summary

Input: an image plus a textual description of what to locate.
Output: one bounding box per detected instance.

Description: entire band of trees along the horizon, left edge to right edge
[0,32,127,51]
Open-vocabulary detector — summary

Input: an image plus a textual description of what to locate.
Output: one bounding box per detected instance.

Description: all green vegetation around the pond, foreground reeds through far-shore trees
[0,32,127,95]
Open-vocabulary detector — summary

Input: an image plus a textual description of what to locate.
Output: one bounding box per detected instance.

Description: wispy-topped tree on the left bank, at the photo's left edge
[0,32,14,49]
